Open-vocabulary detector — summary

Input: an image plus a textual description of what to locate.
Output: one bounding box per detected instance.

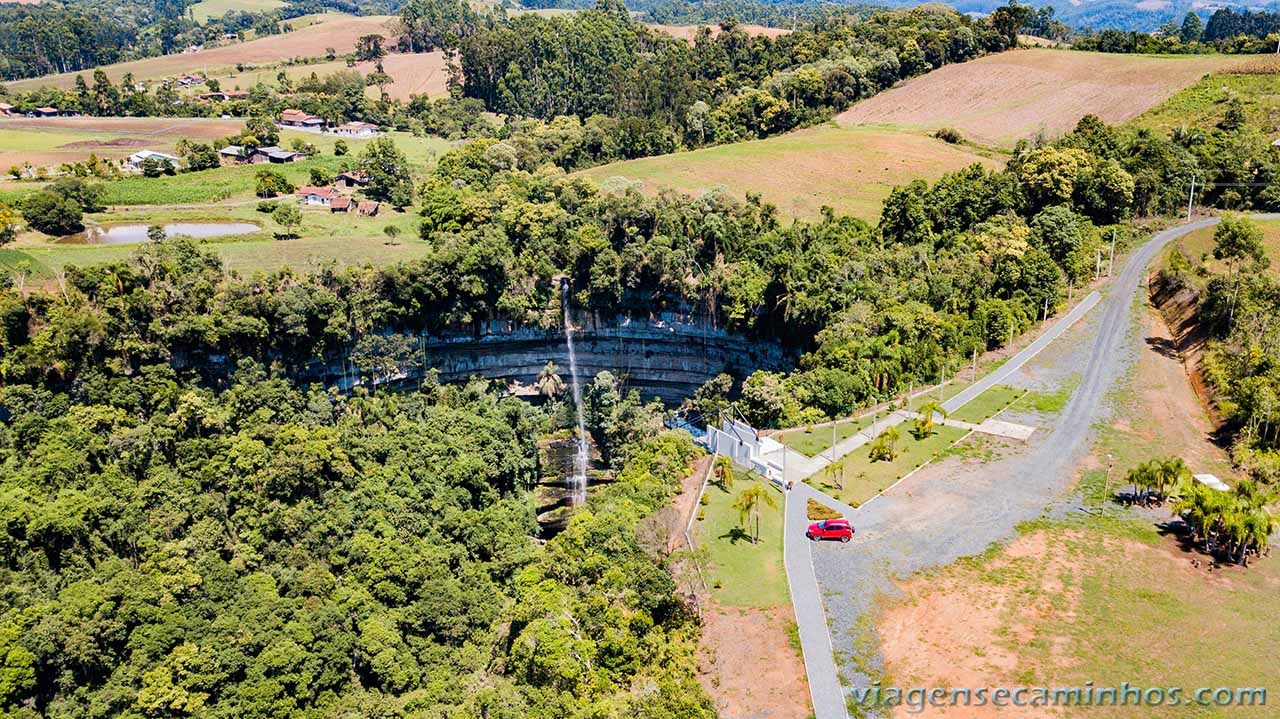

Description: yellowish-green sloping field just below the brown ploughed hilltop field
[581,125,1002,221]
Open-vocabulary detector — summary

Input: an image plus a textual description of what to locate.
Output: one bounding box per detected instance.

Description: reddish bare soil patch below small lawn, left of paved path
[698,605,813,719]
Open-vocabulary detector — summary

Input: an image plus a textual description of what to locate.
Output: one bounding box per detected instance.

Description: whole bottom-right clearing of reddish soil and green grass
[877,517,1280,719]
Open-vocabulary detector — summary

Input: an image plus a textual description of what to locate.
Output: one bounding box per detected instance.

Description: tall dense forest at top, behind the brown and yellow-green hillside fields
[458,0,1025,151]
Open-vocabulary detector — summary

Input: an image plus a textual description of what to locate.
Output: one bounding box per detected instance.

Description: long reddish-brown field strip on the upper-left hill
[8,13,393,91]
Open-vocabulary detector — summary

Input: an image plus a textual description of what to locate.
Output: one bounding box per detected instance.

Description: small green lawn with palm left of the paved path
[695,472,791,608]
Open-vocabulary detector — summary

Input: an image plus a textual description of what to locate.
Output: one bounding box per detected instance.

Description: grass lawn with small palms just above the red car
[805,422,968,507]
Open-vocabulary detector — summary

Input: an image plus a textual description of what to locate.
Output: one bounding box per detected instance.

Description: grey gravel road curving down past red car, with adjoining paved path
[785,215,1280,719]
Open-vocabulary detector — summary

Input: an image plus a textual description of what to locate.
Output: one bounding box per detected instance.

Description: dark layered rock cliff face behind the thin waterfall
[412,313,794,403]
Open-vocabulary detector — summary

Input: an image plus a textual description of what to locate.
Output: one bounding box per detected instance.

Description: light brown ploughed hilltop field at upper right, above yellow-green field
[837,47,1248,147]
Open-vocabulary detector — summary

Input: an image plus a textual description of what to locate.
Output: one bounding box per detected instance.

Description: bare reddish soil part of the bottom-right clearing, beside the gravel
[878,530,1236,719]
